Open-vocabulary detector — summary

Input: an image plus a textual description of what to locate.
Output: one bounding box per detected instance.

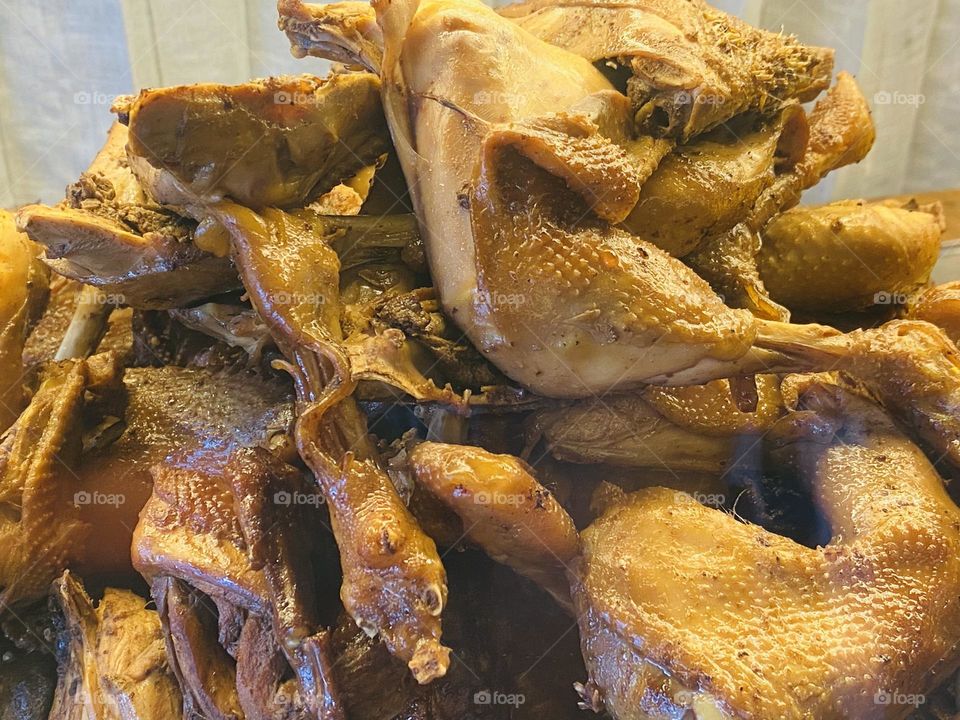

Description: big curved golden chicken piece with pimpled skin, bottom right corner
[573,384,960,720]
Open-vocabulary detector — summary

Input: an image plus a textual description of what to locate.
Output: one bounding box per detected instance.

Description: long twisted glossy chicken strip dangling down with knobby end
[213,203,449,683]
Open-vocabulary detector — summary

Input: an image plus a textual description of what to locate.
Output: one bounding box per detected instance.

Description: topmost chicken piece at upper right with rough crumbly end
[500,0,833,140]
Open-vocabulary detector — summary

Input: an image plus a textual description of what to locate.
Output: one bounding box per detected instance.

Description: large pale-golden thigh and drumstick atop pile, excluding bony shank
[377,0,780,396]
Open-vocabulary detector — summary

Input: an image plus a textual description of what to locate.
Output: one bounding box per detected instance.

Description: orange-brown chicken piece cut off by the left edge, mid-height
[0,210,50,433]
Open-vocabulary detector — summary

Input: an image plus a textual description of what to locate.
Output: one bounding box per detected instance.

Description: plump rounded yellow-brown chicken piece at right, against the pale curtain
[759,200,944,313]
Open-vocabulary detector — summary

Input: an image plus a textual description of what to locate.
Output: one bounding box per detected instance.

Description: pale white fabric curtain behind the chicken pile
[0,0,960,207]
